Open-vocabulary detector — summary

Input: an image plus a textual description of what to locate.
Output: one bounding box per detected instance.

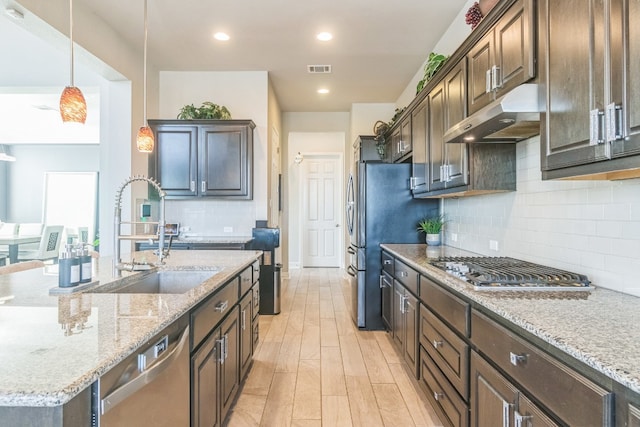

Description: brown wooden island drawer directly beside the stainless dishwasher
[191,277,239,349]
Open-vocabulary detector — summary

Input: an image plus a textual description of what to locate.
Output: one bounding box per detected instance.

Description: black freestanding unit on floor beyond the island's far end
[250,227,282,314]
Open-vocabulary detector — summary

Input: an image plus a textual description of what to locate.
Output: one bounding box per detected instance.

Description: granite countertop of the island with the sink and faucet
[0,250,262,407]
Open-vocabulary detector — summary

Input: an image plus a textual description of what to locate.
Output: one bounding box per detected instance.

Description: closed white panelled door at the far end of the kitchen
[301,154,342,267]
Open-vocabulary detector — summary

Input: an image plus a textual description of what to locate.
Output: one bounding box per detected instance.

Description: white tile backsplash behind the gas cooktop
[444,137,640,296]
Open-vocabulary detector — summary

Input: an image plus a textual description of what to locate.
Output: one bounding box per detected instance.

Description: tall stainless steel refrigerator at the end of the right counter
[346,137,439,329]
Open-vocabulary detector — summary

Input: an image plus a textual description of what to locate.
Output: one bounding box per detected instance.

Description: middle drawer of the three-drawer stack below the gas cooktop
[420,305,469,400]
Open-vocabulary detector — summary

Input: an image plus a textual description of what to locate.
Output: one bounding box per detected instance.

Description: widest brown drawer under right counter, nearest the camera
[471,311,613,426]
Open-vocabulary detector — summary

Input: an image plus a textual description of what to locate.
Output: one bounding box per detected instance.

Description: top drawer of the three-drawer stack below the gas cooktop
[420,276,471,337]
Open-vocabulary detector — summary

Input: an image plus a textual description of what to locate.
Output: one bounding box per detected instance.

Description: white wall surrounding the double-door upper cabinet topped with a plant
[160,71,270,236]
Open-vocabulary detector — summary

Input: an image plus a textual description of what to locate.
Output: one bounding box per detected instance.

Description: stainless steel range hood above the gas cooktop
[444,84,540,143]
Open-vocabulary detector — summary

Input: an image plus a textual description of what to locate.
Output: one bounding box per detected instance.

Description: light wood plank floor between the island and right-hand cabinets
[228,268,441,427]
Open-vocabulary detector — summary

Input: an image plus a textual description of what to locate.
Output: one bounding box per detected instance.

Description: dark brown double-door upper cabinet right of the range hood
[538,0,640,179]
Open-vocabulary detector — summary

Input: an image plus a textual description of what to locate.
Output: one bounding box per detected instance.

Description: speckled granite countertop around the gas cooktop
[381,244,640,393]
